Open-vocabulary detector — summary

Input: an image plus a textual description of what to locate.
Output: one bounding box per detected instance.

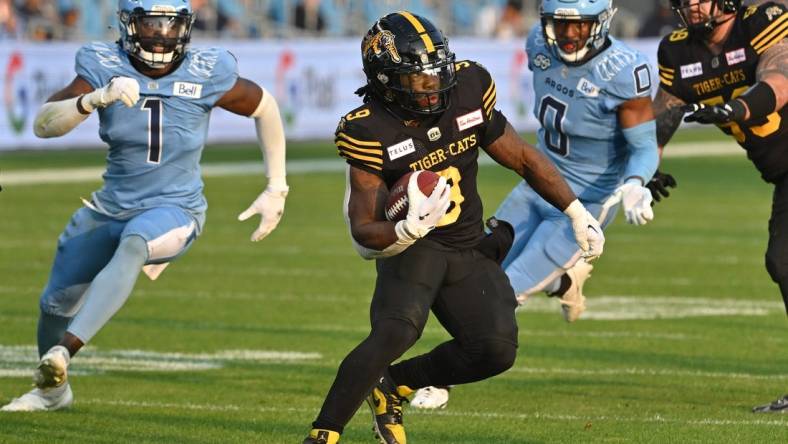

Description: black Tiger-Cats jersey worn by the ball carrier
[334,61,506,248]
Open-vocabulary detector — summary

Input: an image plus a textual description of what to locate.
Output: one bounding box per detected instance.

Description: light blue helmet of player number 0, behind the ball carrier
[539,0,617,65]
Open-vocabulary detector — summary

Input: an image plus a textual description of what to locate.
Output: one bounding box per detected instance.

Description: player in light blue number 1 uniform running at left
[2,0,288,411]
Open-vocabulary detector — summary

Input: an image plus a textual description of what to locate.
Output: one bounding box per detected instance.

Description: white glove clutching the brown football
[394,171,451,242]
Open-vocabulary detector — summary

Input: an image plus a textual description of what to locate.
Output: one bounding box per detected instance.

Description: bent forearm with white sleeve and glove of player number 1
[33,76,140,138]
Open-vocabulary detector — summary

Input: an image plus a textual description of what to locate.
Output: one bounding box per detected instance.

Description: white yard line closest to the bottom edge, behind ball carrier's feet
[76,399,788,428]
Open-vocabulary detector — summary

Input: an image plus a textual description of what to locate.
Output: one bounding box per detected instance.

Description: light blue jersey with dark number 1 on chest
[76,42,238,225]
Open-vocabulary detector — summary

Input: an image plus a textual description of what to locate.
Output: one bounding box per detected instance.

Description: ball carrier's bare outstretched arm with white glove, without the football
[485,123,605,260]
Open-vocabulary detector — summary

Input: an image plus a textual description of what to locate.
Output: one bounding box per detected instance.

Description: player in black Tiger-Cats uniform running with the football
[304,11,604,444]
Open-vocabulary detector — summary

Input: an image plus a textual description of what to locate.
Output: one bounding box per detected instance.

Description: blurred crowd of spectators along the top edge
[0,0,785,41]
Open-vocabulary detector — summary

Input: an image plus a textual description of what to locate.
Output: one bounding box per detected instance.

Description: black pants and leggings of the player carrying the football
[314,239,517,433]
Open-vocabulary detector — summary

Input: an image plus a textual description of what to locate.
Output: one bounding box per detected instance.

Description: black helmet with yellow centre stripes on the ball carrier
[361,11,457,115]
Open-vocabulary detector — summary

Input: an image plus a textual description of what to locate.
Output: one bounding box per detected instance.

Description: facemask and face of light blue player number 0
[541,9,617,65]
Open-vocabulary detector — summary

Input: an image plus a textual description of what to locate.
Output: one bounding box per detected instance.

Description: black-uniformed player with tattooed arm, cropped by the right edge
[651,0,788,412]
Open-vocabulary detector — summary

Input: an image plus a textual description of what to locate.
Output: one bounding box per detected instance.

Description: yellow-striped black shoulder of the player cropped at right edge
[741,2,788,54]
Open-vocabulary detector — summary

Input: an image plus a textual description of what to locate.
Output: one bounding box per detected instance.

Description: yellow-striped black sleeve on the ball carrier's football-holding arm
[334,117,383,177]
